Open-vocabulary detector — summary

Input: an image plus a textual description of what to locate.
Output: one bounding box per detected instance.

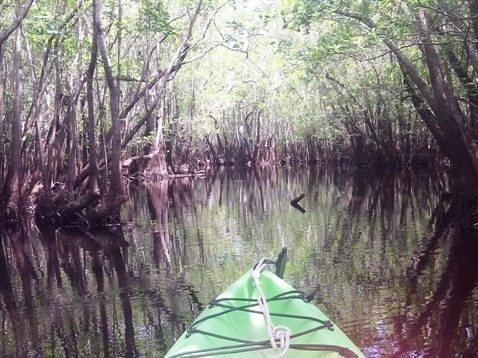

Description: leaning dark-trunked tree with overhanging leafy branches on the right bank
[284,0,478,213]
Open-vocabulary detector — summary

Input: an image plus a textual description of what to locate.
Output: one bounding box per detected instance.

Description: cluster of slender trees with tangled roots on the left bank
[0,0,228,224]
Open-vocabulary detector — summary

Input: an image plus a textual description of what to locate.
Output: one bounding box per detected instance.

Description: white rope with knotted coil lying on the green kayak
[251,259,291,358]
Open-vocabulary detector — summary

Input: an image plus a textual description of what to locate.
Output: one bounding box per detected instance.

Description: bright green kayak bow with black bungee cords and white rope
[165,250,365,358]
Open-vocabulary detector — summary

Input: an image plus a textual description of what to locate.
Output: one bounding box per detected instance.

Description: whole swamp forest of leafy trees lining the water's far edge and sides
[0,0,478,226]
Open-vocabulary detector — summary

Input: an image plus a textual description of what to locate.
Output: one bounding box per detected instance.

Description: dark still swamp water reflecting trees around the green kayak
[0,169,478,357]
